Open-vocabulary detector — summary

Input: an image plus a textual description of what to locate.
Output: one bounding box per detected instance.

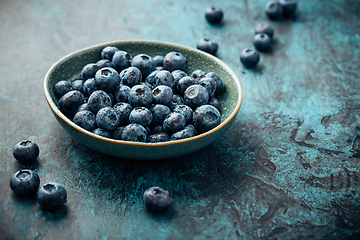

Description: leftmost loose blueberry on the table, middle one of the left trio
[10,169,40,196]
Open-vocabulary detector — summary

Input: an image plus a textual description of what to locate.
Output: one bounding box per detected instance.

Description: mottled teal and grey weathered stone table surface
[0,0,360,239]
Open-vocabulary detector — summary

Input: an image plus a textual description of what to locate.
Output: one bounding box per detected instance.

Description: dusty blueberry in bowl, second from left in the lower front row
[96,107,120,131]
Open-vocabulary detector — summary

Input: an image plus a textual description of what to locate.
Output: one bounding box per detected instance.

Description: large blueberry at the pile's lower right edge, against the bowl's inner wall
[193,105,221,133]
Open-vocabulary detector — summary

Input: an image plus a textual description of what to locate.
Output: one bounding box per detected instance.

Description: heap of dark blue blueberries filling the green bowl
[54,46,225,143]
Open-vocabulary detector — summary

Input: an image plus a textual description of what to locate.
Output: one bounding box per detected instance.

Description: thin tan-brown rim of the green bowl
[43,40,243,147]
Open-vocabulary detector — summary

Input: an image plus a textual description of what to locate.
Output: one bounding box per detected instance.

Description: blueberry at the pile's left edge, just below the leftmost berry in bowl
[59,90,85,113]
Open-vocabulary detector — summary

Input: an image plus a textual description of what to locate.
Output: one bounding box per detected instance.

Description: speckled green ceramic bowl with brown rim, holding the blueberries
[44,40,243,160]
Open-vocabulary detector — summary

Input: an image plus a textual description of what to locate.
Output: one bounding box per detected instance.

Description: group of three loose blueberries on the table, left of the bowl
[10,140,67,211]
